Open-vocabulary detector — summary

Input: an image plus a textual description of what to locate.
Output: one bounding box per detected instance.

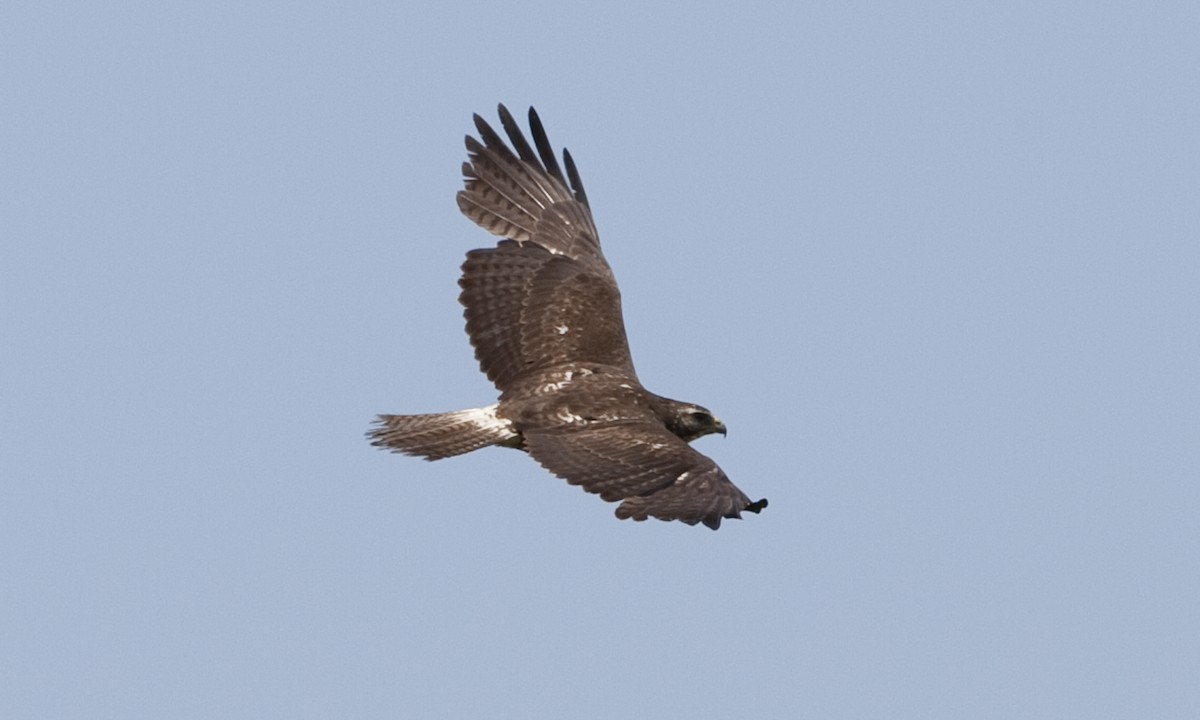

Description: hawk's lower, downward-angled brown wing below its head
[524,421,767,530]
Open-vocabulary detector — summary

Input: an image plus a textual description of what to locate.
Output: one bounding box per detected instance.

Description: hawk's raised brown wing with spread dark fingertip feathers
[458,106,634,391]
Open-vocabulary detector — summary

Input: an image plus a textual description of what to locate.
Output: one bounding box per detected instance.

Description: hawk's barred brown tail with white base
[367,404,521,460]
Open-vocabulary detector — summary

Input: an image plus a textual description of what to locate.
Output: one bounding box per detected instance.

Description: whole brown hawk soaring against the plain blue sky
[367,104,767,530]
